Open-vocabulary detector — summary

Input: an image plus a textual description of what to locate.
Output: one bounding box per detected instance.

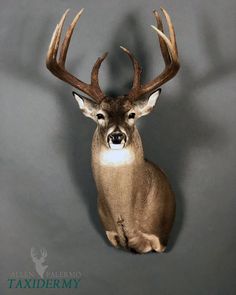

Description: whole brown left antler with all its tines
[46,9,107,103]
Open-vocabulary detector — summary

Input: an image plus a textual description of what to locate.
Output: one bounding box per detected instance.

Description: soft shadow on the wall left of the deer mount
[1,13,107,242]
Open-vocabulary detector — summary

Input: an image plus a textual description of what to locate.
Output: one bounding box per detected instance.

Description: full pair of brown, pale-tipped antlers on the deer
[46,8,180,103]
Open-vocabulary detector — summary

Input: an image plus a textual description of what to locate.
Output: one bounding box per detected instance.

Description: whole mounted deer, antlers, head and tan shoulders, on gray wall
[46,8,179,253]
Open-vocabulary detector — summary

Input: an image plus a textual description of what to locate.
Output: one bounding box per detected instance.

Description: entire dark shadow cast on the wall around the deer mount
[1,9,236,249]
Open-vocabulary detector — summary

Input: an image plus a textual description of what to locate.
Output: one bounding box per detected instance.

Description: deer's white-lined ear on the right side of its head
[135,88,161,117]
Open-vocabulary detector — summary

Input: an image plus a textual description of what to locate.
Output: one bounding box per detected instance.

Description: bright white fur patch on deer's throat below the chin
[99,148,134,166]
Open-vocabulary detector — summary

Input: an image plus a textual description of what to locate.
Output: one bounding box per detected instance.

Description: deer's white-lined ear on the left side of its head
[72,91,98,121]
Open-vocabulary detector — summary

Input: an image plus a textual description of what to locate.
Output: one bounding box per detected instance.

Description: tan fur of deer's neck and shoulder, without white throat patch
[92,128,175,253]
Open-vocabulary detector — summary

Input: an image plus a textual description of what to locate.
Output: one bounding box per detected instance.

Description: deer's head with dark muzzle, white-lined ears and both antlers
[46,8,179,149]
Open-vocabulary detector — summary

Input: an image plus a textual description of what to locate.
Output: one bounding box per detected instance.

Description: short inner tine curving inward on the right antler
[120,46,142,99]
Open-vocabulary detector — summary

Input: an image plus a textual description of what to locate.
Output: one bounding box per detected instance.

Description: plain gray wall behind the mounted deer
[0,0,236,295]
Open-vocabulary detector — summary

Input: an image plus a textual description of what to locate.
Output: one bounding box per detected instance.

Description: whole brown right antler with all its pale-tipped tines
[121,8,180,100]
